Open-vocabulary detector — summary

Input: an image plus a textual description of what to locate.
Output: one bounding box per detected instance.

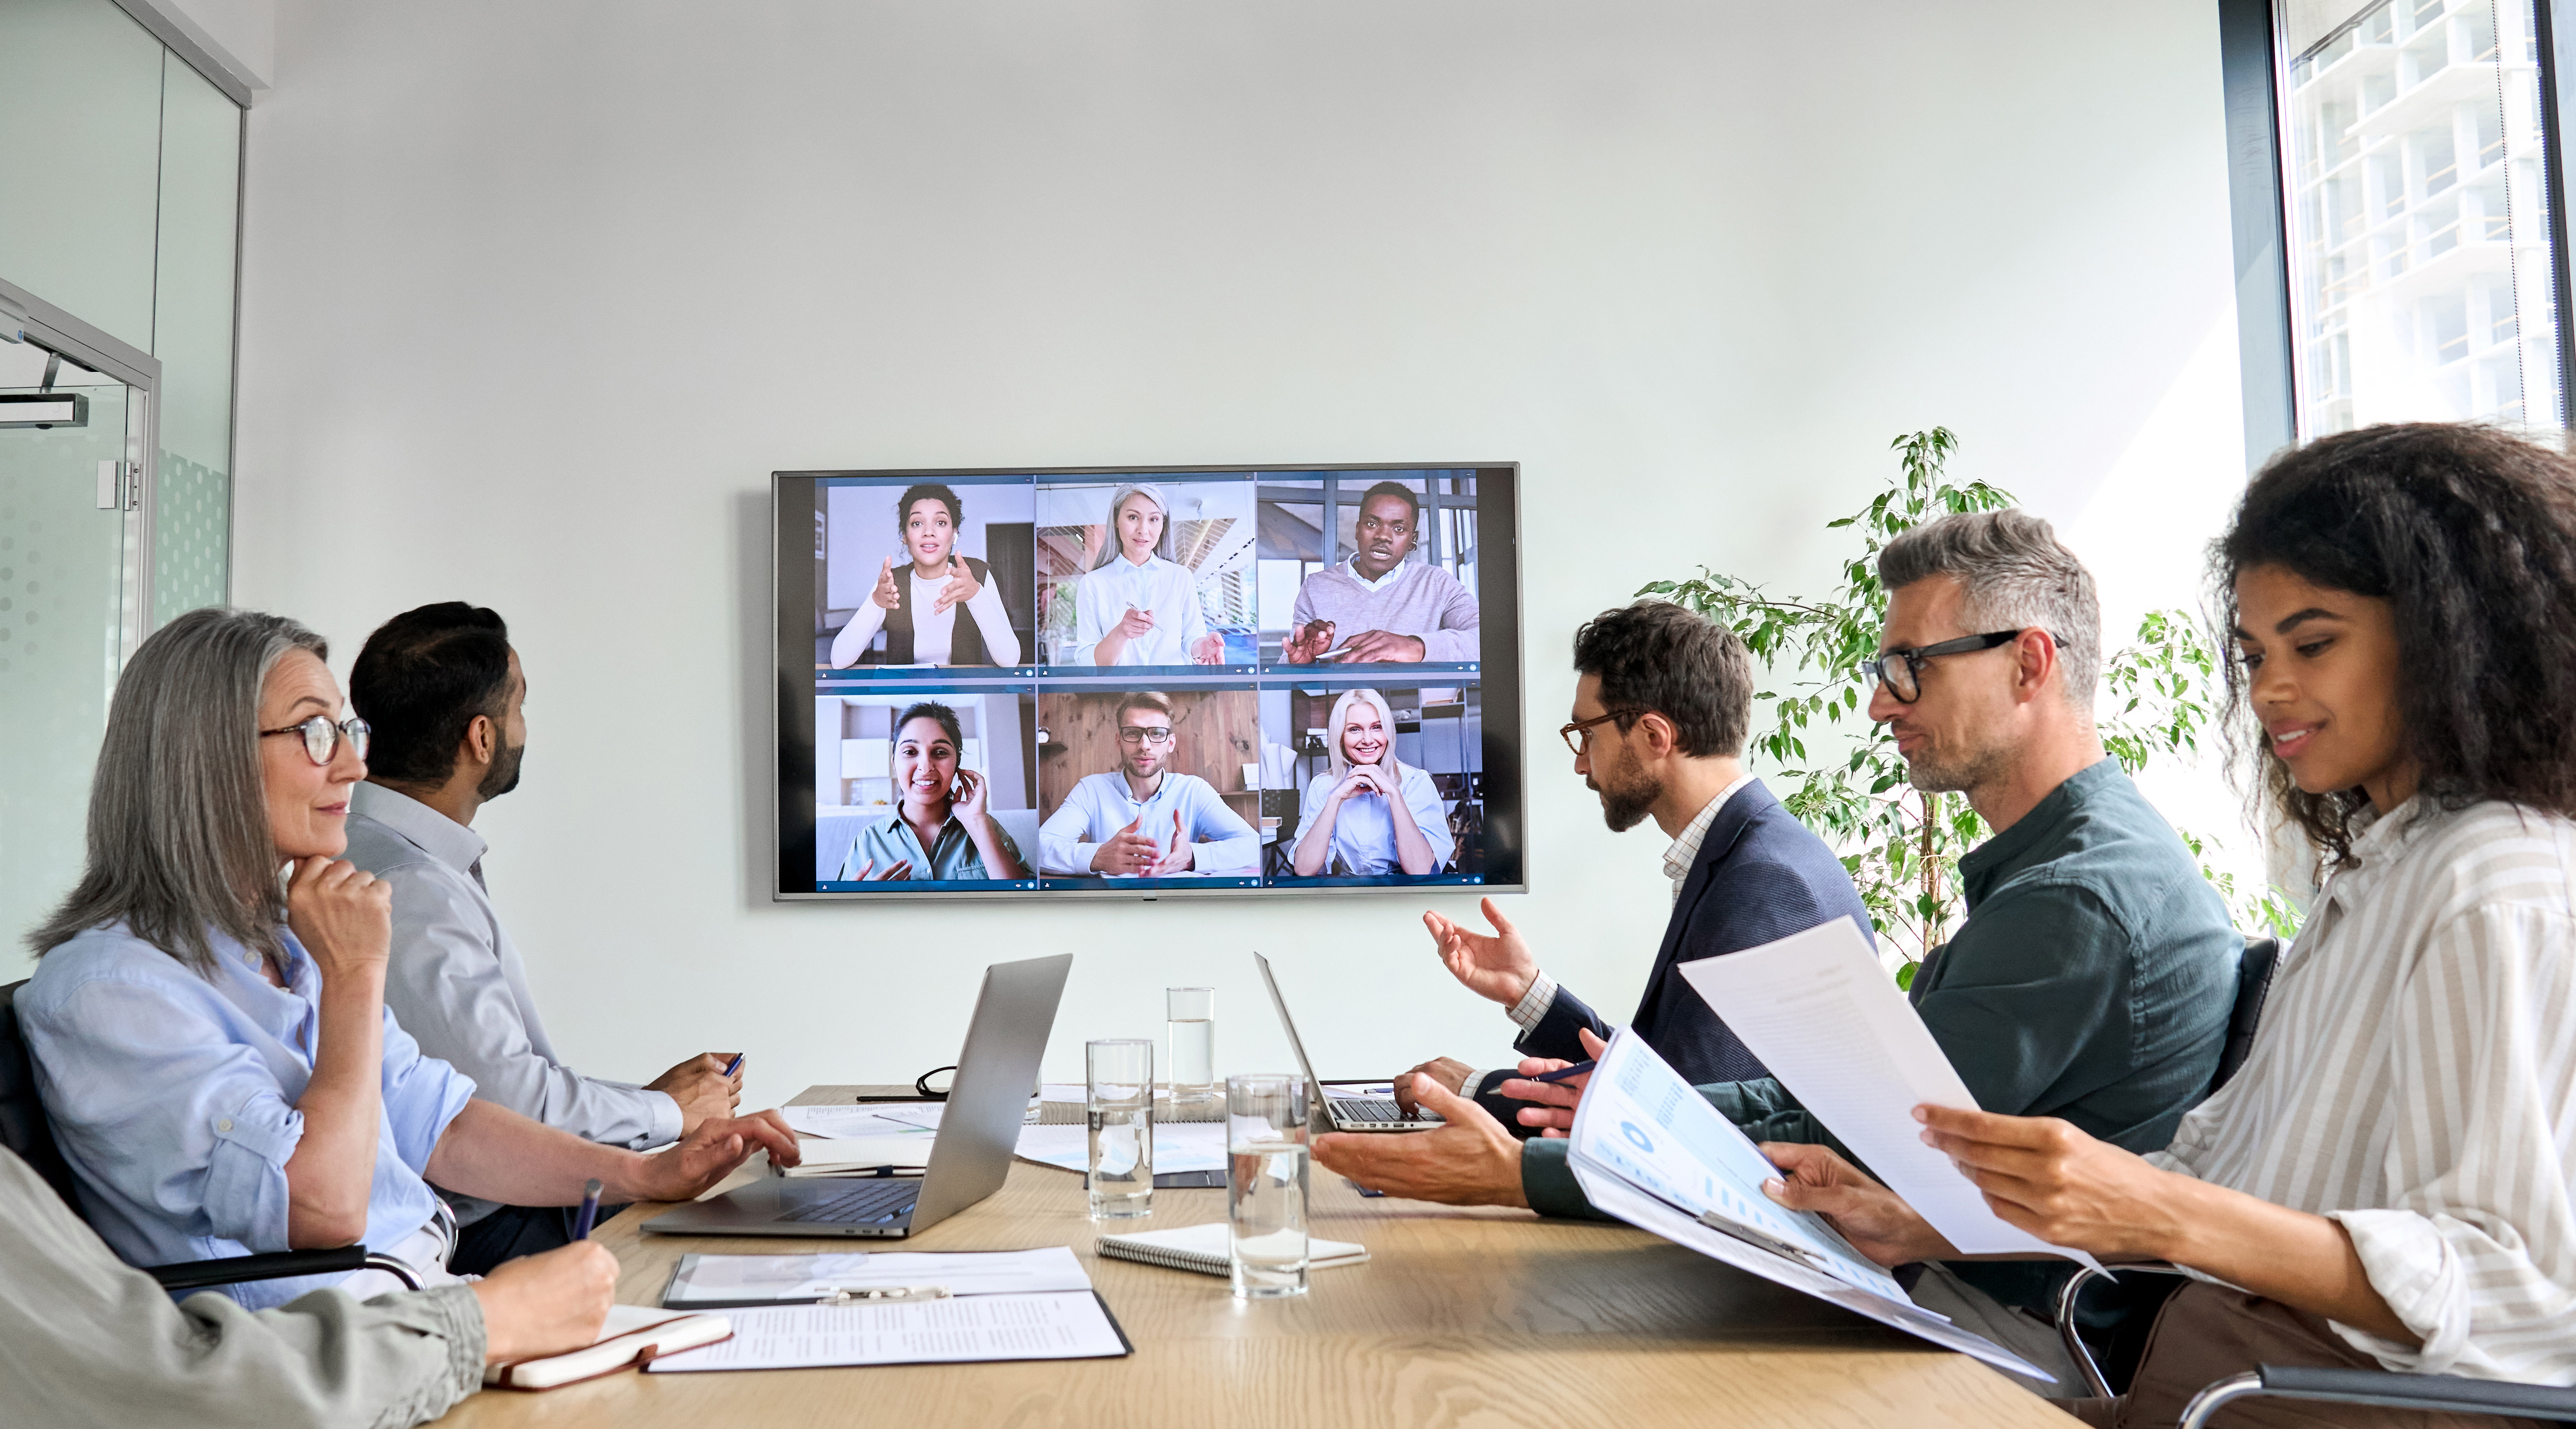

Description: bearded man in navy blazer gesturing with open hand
[1396,600,1870,1135]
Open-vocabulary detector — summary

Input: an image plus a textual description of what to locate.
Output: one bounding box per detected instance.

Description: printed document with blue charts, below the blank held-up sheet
[1569,1027,2050,1380]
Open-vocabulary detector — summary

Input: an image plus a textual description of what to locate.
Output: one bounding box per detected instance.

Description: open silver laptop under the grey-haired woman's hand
[644,953,1074,1239]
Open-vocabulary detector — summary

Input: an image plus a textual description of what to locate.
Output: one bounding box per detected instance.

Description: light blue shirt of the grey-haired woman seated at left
[18,924,474,1311]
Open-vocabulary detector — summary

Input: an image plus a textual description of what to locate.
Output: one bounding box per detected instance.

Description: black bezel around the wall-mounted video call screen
[768,461,1530,904]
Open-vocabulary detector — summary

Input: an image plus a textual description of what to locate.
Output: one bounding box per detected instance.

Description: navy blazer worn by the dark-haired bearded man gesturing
[1476,780,1876,1112]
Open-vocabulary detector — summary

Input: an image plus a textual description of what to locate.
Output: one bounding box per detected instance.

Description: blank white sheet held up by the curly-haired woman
[1682,917,2099,1269]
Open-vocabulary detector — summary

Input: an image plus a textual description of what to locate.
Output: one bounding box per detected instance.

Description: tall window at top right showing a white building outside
[2220,0,2568,448]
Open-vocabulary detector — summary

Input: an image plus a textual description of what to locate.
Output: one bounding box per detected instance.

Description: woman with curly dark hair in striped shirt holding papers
[1764,425,2576,1426]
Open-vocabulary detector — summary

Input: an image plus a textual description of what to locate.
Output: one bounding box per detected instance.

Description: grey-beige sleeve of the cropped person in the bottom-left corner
[0,1148,485,1429]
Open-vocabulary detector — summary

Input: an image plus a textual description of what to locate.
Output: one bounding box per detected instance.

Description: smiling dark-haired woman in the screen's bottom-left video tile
[840,700,1028,883]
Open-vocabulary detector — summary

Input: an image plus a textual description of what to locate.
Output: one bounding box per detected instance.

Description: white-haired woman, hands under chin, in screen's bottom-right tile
[1296,690,1458,878]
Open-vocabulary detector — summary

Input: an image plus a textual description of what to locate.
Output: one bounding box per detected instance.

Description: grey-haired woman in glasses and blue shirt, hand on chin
[18,610,796,1311]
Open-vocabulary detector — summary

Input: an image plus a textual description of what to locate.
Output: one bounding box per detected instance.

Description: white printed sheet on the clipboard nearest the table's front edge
[644,1290,1128,1375]
